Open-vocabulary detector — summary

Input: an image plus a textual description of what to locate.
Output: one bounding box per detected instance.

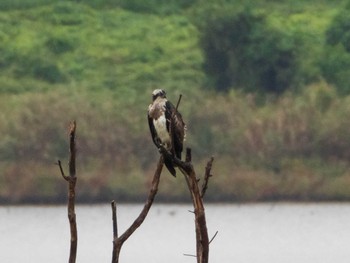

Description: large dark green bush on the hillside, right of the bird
[200,9,298,93]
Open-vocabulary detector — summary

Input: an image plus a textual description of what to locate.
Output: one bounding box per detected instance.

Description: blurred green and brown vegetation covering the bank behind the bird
[0,0,350,202]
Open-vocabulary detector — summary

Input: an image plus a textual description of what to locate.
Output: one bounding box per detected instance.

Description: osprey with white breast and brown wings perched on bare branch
[148,89,186,176]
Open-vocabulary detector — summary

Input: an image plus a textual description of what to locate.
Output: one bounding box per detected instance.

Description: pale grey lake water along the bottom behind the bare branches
[0,203,350,263]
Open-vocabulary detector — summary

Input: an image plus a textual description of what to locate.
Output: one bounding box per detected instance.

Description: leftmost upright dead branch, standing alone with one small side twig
[57,121,78,263]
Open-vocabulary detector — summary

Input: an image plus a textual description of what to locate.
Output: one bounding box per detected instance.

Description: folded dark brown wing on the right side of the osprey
[165,101,186,159]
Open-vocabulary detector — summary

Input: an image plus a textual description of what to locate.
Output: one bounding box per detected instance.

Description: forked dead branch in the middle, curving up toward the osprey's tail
[112,156,164,263]
